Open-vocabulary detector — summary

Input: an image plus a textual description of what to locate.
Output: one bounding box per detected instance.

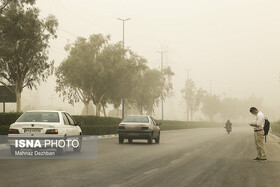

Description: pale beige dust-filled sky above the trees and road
[15,0,280,119]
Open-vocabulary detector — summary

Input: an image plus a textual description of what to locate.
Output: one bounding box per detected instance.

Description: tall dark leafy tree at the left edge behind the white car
[0,0,58,112]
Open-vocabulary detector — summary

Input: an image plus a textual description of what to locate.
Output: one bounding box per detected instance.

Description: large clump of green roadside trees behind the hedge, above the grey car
[55,34,174,117]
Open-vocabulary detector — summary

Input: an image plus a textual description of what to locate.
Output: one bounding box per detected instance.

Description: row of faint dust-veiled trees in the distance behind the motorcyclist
[181,78,268,121]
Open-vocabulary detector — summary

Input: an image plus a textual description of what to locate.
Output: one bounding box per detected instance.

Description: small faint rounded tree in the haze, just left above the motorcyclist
[202,94,221,121]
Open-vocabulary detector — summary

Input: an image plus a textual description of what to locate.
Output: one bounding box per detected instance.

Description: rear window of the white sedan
[17,112,59,123]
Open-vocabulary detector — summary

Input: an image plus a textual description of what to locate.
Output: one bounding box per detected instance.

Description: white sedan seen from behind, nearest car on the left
[8,110,82,155]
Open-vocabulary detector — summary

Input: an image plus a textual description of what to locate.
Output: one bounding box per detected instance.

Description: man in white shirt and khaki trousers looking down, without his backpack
[250,107,267,161]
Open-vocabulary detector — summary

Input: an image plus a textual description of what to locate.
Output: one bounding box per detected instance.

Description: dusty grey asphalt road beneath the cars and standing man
[0,127,280,187]
